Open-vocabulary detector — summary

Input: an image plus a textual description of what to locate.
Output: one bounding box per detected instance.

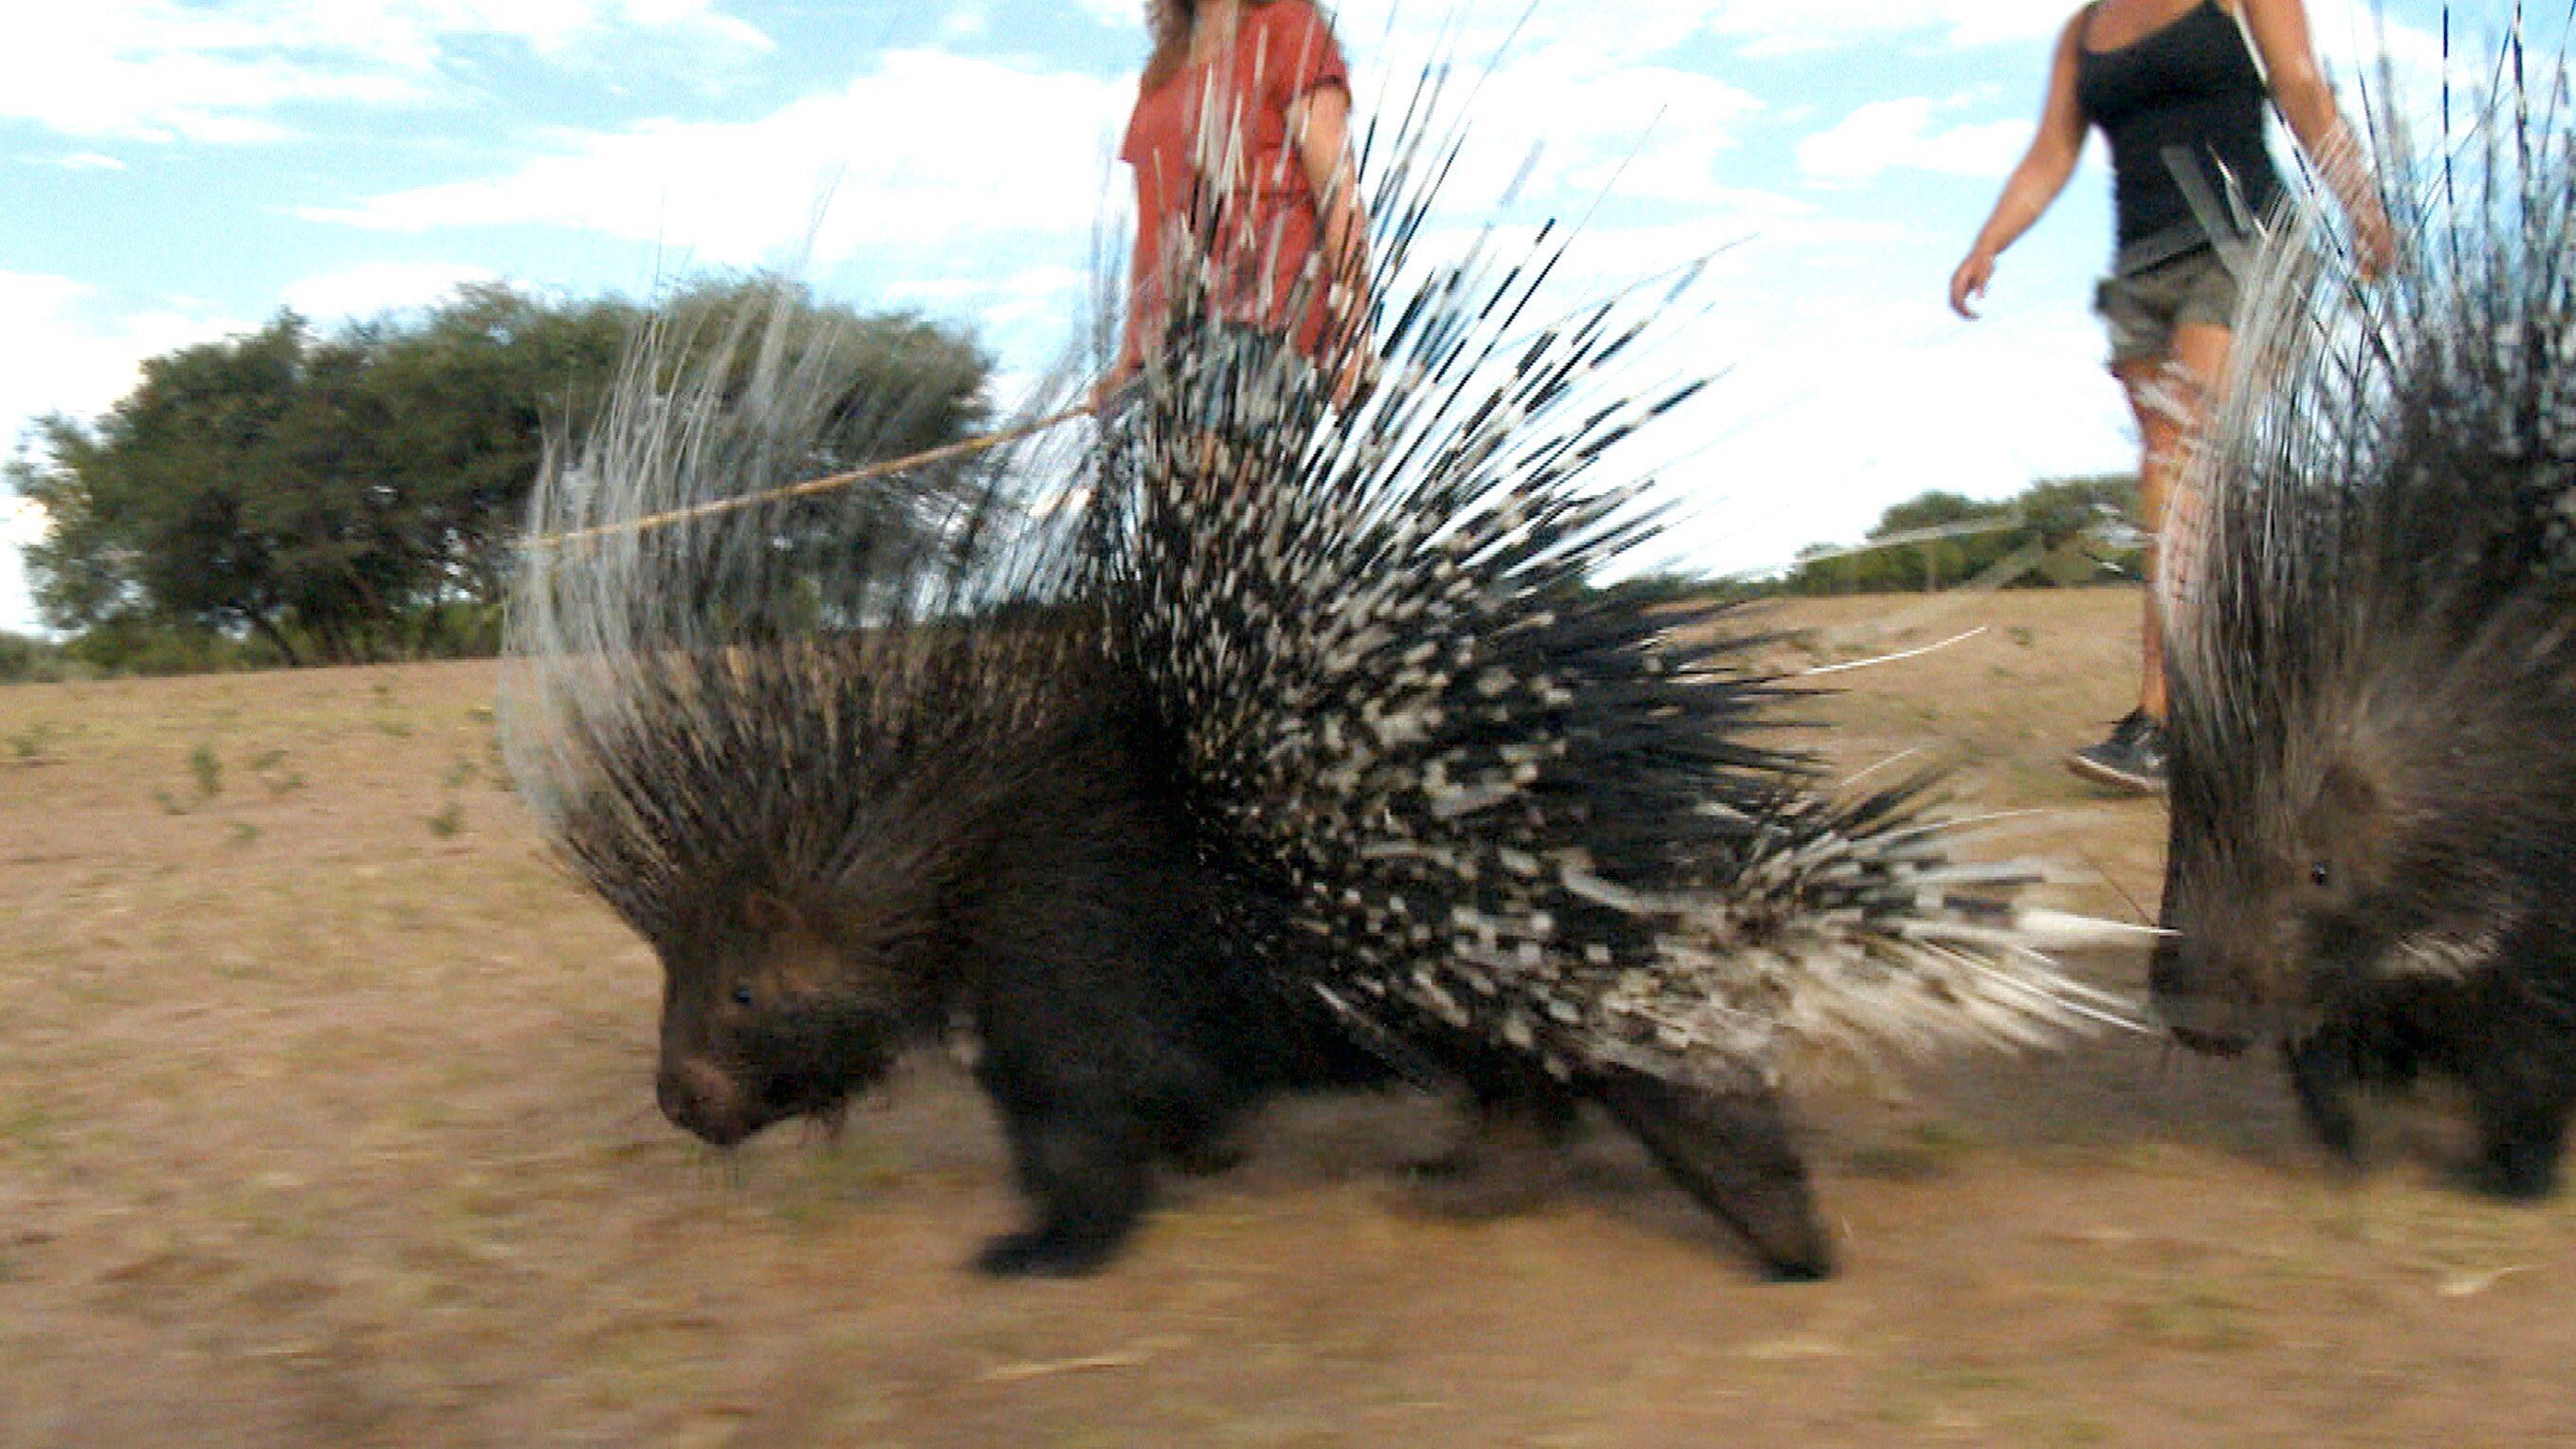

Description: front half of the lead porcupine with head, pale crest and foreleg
[502,297,1376,1271]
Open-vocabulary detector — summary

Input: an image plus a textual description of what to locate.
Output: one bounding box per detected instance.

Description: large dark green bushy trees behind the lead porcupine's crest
[0,276,989,678]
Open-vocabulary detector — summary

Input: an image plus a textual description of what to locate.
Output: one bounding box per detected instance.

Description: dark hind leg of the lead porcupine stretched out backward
[1598,1073,1835,1281]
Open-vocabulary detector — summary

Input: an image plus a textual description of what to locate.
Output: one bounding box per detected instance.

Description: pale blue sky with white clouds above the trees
[0,0,2501,629]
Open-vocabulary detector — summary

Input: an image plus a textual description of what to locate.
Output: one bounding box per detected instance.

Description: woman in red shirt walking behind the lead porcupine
[1100,0,1368,405]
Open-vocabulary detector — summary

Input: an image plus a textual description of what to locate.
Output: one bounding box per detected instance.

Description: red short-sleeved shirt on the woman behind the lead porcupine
[1118,0,1350,356]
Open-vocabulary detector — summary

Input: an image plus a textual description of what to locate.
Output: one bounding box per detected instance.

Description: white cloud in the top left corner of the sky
[0,0,768,142]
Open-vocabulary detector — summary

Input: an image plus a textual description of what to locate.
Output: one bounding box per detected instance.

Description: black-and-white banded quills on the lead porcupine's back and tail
[1097,28,2126,1083]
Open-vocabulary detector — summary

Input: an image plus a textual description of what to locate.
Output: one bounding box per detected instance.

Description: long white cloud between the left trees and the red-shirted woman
[306,51,1128,266]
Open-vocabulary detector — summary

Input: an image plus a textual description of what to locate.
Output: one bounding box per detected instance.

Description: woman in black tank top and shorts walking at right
[1950,0,2393,792]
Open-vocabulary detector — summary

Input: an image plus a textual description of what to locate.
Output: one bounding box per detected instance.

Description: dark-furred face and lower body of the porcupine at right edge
[2151,632,2576,1197]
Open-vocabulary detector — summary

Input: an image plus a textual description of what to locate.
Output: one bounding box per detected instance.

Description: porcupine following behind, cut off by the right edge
[2151,15,2576,1197]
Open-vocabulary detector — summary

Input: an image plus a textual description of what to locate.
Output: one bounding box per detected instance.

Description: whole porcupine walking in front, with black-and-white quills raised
[510,50,2132,1276]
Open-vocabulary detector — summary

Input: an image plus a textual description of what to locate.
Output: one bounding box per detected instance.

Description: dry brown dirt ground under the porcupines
[0,593,2576,1449]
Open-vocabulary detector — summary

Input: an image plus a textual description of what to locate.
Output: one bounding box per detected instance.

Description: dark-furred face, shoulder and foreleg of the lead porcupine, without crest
[644,660,1386,1274]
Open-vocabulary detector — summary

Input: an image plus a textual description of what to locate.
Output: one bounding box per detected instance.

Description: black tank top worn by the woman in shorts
[2076,0,2280,255]
